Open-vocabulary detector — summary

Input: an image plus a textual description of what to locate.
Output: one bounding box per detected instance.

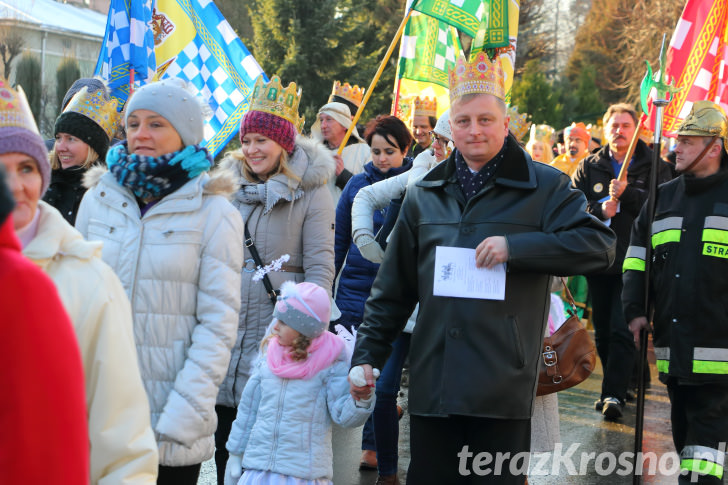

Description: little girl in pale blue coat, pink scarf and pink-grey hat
[225,282,374,485]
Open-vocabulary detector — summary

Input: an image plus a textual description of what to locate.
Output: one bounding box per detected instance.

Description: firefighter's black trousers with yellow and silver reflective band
[667,378,728,485]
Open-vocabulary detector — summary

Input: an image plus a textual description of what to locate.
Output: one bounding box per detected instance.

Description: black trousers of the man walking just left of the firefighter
[587,275,636,404]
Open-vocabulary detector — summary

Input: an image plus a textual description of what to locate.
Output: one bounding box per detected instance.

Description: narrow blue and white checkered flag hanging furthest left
[94,0,157,105]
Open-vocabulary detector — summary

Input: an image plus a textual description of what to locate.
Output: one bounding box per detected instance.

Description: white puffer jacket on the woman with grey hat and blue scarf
[76,168,243,466]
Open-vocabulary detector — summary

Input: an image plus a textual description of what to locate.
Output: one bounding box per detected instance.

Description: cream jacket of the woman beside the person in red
[23,201,158,485]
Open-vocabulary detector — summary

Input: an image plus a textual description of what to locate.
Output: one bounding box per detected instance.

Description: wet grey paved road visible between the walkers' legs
[199,332,728,485]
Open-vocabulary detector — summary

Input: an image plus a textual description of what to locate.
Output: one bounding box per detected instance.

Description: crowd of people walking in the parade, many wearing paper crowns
[0,41,728,485]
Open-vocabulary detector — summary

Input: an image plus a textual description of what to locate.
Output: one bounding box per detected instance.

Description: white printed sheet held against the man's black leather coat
[433,246,506,300]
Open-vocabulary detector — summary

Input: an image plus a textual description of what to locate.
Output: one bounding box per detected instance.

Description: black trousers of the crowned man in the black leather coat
[407,416,531,485]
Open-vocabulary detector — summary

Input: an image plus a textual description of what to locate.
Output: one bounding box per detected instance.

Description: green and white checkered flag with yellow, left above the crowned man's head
[399,12,460,88]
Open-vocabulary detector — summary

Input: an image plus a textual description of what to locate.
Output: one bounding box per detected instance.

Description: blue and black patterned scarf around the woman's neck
[106,141,214,199]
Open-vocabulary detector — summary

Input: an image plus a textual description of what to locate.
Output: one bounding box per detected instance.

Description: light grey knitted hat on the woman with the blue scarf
[124,78,205,146]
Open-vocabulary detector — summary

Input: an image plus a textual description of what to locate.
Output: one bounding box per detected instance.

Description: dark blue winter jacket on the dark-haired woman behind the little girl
[334,158,412,326]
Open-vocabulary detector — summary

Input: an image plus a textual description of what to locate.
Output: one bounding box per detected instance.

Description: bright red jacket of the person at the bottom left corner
[0,216,89,485]
